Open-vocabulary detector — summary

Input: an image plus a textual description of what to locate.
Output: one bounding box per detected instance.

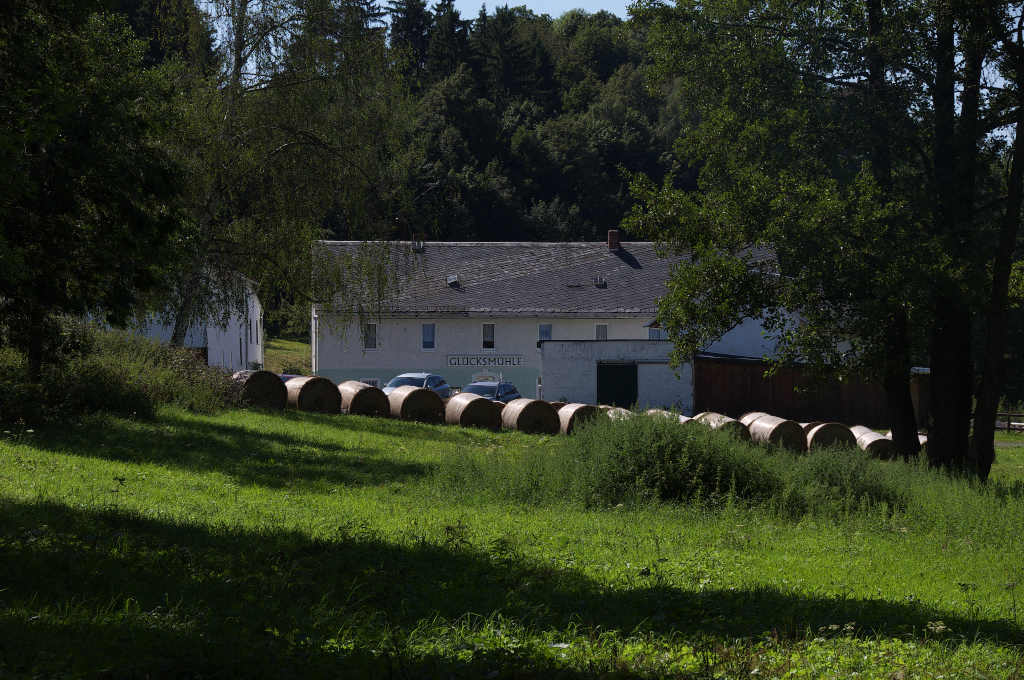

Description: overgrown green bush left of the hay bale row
[0,321,238,424]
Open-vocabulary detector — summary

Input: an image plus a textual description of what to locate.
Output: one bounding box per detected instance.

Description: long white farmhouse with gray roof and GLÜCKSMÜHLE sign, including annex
[311,230,772,412]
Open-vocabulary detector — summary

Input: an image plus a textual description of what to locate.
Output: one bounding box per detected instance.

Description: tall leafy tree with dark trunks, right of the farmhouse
[630,0,1011,466]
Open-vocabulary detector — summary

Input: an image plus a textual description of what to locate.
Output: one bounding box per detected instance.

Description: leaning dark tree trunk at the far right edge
[971,79,1024,479]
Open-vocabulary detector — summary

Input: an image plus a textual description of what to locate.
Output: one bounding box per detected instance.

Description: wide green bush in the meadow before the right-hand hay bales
[435,414,977,516]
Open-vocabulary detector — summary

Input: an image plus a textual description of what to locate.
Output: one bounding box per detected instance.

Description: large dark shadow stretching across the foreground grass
[0,500,1021,678]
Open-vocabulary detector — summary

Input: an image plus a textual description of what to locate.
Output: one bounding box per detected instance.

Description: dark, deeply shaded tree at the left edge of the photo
[0,0,178,374]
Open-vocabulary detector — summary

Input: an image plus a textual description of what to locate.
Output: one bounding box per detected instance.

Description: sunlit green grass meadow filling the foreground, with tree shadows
[0,409,1024,678]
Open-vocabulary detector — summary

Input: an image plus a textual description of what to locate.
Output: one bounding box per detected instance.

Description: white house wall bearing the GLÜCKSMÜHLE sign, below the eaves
[312,316,650,396]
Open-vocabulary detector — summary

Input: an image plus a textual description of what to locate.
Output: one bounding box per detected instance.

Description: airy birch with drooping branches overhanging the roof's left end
[152,0,411,343]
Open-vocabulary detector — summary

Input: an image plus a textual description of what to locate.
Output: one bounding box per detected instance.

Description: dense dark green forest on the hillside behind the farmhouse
[120,0,679,241]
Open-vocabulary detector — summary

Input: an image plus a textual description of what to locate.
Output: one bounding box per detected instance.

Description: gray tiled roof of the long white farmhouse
[326,241,767,316]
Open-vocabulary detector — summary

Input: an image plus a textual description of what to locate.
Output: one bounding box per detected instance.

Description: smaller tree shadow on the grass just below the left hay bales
[23,411,472,487]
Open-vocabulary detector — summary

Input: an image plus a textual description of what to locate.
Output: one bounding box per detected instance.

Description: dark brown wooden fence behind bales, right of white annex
[693,357,927,429]
